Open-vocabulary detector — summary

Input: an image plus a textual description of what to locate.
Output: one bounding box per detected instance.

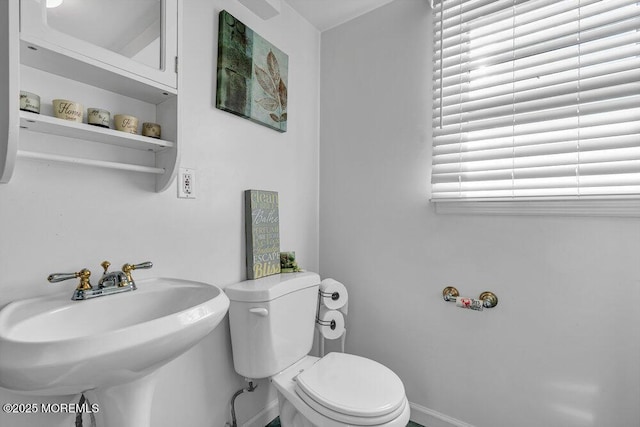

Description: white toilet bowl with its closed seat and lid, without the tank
[271,353,410,427]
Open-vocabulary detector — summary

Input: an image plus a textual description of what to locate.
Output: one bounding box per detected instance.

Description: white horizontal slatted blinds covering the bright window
[432,0,640,199]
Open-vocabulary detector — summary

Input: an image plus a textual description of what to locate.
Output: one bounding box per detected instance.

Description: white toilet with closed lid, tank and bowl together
[225,272,410,427]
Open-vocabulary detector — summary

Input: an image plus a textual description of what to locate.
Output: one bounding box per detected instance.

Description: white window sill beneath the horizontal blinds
[431,199,640,218]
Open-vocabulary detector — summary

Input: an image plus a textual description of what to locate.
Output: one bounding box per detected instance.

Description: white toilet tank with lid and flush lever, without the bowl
[225,272,320,379]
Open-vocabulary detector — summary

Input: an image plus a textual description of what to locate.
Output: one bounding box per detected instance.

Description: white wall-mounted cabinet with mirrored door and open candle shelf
[0,0,181,191]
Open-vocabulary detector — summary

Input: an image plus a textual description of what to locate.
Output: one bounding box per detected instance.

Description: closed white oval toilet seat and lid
[295,353,407,426]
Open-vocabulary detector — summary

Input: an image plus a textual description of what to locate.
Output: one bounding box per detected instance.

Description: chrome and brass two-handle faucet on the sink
[47,261,153,300]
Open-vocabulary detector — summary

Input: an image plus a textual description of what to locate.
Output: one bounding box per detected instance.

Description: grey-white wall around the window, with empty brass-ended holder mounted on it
[320,0,640,427]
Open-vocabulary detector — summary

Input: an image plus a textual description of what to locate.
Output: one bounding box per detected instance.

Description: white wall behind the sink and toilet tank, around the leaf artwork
[0,0,320,427]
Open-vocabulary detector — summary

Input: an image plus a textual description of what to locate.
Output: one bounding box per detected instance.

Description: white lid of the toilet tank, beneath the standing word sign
[224,271,320,302]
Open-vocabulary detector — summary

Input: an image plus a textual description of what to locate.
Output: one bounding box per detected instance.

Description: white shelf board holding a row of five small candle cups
[20,111,175,152]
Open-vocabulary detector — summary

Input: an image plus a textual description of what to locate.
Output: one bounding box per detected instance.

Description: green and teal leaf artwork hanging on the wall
[216,10,289,132]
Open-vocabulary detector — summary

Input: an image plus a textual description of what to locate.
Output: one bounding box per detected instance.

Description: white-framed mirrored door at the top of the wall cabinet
[20,0,178,88]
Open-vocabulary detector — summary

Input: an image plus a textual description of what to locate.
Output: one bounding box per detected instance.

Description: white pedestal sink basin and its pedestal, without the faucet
[0,278,229,427]
